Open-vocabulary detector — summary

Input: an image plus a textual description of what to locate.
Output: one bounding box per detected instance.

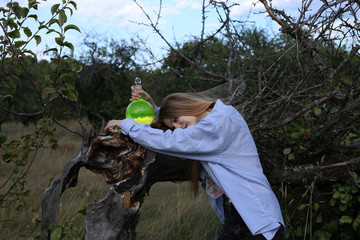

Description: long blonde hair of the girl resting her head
[153,93,215,195]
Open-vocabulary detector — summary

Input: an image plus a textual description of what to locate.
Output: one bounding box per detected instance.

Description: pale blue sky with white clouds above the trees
[0,0,320,62]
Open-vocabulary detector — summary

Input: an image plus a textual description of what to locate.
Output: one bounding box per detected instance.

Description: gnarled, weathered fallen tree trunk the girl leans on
[41,126,189,240]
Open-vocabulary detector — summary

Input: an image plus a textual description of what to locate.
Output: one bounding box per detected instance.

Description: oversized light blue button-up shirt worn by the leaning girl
[120,100,284,239]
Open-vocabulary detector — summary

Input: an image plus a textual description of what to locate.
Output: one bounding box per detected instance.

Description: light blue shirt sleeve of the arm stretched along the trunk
[120,113,224,162]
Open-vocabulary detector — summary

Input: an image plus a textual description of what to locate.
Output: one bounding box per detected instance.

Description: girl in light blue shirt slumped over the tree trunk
[105,87,284,240]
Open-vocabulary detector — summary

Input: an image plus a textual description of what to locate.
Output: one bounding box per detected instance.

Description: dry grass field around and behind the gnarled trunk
[0,122,221,240]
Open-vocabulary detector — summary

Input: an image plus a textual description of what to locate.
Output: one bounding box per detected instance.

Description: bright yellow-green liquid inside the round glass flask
[126,99,155,124]
